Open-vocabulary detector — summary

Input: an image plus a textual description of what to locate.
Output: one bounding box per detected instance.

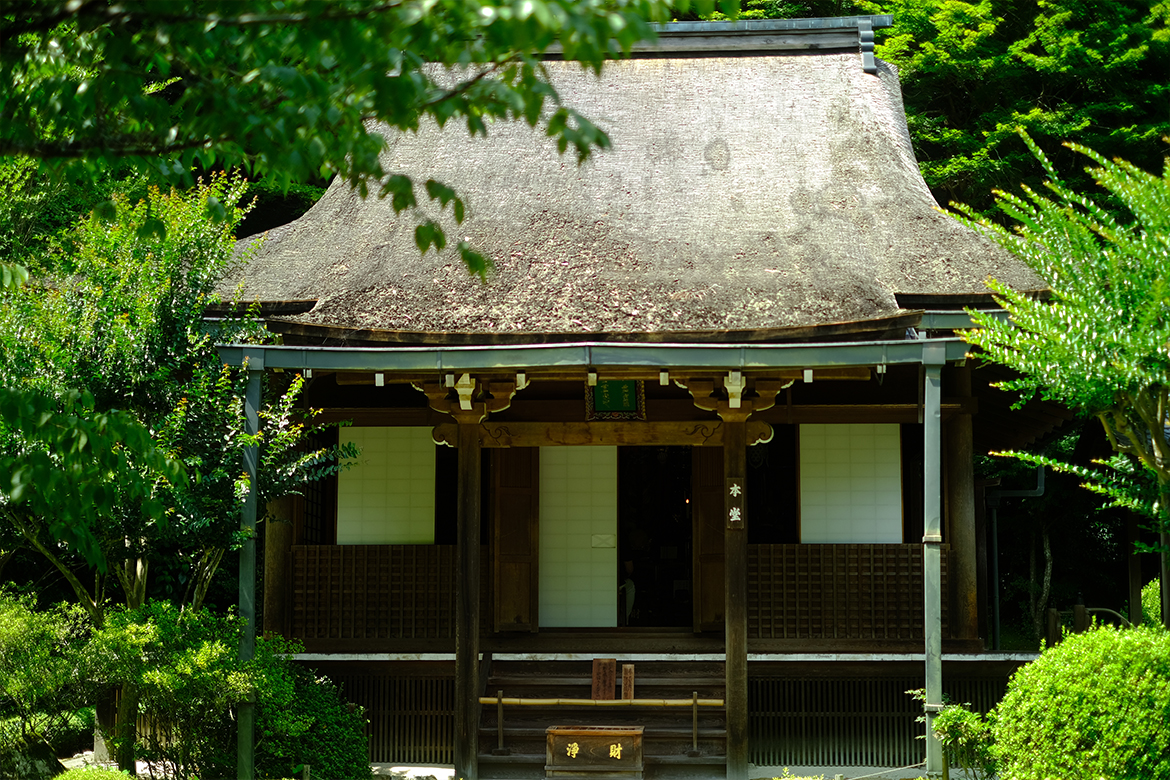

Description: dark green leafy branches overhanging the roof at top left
[0,0,736,270]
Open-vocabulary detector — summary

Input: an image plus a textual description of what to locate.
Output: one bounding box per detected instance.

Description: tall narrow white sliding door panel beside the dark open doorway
[541,447,618,628]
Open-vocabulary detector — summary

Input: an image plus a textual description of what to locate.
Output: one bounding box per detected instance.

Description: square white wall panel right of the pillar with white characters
[800,423,902,544]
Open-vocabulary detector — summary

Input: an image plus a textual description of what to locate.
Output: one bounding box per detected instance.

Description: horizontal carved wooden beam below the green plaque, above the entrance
[432,420,772,448]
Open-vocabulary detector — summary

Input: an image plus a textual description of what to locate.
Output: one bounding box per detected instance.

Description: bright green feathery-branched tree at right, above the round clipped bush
[964,134,1170,626]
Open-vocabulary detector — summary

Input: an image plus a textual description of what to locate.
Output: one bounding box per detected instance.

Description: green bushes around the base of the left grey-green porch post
[89,601,370,780]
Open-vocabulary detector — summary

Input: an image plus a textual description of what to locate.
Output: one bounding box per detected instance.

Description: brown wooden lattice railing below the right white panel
[748,544,950,640]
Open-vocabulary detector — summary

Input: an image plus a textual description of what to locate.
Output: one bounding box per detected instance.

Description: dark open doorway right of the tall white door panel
[618,447,691,628]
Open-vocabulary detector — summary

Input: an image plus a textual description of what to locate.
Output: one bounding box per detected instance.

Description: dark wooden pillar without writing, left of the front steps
[455,415,481,780]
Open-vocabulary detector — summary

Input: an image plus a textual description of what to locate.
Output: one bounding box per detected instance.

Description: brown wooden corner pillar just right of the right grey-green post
[945,366,979,640]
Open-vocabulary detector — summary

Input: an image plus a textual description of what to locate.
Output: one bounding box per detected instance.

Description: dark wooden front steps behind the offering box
[479,661,727,780]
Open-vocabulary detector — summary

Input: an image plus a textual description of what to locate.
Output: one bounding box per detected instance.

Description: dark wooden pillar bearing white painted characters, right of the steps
[721,410,748,780]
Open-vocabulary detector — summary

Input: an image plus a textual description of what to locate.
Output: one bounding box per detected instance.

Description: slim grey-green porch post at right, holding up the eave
[922,356,943,772]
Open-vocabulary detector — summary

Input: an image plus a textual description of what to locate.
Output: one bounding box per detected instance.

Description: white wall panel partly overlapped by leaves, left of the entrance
[337,427,435,545]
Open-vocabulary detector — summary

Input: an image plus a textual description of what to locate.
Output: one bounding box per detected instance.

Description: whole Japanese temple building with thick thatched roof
[221,16,1066,780]
